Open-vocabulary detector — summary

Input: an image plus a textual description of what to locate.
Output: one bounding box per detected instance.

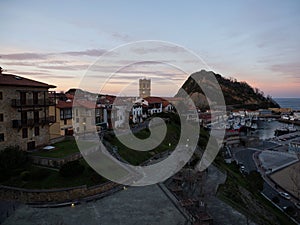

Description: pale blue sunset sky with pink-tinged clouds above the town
[0,0,300,97]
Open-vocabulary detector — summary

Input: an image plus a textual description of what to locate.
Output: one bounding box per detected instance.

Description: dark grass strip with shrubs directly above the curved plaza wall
[2,159,107,189]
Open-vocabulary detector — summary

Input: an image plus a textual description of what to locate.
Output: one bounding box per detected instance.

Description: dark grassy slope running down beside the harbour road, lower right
[215,157,294,225]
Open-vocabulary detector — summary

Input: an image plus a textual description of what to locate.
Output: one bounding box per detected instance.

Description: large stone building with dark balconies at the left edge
[0,73,56,150]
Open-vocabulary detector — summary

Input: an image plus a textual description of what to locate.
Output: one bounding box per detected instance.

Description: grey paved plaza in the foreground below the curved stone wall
[3,185,186,225]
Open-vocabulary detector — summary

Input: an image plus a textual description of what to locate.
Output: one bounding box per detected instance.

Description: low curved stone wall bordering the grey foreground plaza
[0,182,120,204]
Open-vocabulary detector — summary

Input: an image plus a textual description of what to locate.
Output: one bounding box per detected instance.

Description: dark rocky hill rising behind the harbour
[175,70,280,110]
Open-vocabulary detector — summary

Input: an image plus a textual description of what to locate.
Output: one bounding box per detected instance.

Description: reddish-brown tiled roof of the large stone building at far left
[0,74,56,88]
